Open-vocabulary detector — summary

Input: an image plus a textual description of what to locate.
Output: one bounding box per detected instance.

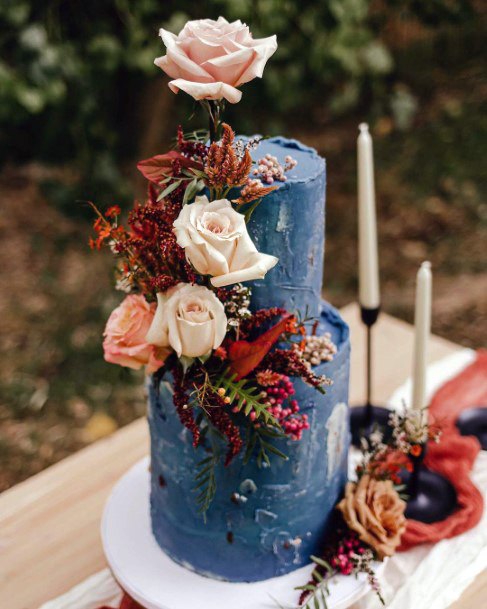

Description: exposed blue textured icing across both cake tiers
[149,138,350,581]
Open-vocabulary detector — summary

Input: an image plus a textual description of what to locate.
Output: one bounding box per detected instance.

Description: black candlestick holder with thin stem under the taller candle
[350,307,391,446]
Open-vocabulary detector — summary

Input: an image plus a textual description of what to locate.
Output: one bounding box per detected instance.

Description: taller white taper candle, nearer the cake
[357,123,380,309]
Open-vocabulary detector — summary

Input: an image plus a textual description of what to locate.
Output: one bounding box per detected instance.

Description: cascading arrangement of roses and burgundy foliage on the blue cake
[90,18,335,513]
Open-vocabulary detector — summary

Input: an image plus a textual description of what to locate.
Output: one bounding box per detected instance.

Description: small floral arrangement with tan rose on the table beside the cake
[298,408,441,609]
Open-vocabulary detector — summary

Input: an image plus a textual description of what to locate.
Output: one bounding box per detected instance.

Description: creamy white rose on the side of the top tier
[174,196,278,288]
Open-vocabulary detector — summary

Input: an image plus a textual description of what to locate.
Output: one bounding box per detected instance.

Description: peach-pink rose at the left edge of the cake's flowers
[103,295,170,374]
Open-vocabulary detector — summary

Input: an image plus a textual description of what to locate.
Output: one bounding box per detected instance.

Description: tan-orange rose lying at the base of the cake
[337,474,406,560]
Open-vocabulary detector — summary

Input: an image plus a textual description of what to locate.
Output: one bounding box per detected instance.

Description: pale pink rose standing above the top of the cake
[154,17,277,104]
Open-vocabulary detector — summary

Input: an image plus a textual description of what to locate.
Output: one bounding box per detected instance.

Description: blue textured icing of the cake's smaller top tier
[248,137,326,317]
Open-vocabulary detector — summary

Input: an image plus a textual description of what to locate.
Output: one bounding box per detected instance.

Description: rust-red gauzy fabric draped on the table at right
[399,351,487,550]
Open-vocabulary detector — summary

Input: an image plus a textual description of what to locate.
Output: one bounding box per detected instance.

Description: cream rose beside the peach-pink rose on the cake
[145,283,227,357]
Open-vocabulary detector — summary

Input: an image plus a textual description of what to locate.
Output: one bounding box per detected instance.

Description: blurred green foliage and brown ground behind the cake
[0,0,487,484]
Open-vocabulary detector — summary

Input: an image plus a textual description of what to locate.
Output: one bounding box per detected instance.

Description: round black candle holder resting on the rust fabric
[402,444,457,524]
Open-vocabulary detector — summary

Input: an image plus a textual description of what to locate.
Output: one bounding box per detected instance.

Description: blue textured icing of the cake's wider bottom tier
[148,303,350,582]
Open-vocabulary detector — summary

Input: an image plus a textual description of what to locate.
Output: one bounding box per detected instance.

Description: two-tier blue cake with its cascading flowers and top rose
[92,13,350,582]
